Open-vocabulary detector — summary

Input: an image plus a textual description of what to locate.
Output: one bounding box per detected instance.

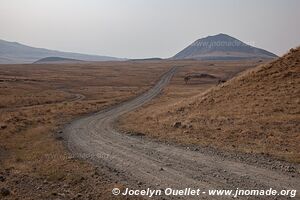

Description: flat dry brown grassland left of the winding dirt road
[0,62,173,199]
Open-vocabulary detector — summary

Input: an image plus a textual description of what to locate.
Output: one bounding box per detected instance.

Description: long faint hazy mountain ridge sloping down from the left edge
[0,40,125,64]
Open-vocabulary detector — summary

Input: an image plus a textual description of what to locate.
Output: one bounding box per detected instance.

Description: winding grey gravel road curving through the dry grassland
[63,67,300,199]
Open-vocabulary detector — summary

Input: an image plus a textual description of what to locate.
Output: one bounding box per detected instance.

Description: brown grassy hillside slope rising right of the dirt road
[122,48,300,162]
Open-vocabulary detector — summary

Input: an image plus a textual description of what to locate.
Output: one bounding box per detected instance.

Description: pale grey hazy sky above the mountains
[0,0,300,58]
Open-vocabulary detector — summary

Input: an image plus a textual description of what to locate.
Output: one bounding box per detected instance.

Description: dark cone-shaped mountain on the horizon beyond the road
[172,33,277,60]
